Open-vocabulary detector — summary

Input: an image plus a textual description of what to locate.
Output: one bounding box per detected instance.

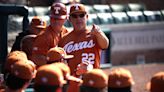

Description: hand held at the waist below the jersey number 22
[76,61,93,75]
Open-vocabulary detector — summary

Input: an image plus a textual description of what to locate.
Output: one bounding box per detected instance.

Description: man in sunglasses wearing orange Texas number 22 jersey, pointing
[59,4,109,92]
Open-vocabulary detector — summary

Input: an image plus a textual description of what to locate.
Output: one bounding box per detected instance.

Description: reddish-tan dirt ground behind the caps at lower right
[104,63,164,92]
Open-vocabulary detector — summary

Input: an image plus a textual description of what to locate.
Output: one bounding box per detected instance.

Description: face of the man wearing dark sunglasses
[70,13,88,30]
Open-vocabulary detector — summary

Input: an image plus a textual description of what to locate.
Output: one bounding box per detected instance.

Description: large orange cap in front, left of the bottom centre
[34,64,66,87]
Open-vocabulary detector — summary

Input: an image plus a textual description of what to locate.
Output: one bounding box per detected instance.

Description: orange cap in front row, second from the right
[108,68,134,88]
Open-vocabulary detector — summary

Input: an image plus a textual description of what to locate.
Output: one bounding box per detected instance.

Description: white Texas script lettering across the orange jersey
[64,40,95,53]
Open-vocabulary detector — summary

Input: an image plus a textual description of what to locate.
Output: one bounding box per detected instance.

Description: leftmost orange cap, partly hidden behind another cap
[4,51,27,72]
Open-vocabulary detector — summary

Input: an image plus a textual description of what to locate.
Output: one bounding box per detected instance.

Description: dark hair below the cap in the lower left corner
[5,74,30,90]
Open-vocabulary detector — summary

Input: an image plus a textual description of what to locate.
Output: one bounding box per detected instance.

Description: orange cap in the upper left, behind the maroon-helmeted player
[30,16,46,29]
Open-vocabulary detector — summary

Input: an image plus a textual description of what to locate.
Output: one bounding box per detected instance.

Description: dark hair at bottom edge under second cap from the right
[108,87,132,92]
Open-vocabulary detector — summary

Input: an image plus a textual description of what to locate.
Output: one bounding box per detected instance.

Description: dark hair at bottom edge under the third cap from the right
[80,86,107,92]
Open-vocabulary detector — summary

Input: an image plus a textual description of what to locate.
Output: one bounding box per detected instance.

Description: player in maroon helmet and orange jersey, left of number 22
[32,2,68,66]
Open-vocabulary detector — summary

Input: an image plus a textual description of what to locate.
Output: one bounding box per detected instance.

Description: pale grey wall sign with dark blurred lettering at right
[111,29,164,51]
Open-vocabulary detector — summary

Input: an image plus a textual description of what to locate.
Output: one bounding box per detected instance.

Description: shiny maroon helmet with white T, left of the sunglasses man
[50,3,67,19]
